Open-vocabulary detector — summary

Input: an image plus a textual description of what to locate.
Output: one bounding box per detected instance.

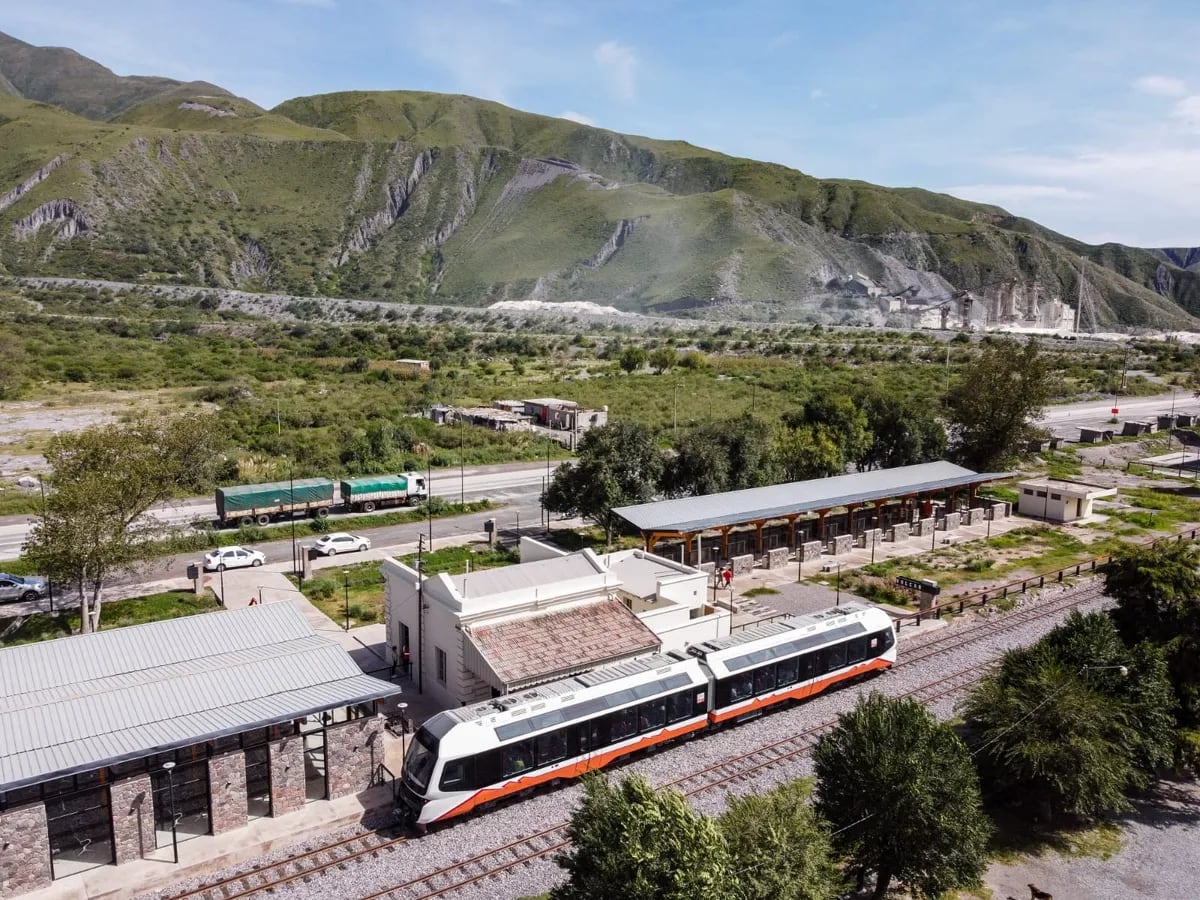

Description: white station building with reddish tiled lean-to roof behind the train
[383,538,732,708]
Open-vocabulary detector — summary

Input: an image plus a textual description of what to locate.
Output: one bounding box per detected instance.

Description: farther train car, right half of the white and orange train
[688,602,896,725]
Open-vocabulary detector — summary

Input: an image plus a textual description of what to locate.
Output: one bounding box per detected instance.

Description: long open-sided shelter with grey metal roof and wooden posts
[613,462,1012,564]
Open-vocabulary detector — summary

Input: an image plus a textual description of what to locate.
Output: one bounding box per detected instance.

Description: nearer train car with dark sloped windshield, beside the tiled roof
[401,655,709,829]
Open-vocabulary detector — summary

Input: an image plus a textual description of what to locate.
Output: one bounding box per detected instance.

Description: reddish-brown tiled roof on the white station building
[466,600,661,690]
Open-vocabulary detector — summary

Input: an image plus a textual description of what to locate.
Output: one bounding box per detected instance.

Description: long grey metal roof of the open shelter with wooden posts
[613,462,1013,533]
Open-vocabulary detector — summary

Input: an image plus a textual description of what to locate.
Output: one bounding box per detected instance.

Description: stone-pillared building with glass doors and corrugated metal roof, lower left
[0,602,400,896]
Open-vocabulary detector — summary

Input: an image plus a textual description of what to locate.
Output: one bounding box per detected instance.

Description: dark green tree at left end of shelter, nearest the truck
[545,421,662,544]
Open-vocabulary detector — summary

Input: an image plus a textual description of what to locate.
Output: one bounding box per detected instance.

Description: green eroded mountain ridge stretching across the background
[0,32,1200,328]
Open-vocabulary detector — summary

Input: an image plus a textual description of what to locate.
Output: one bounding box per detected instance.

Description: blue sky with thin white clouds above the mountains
[0,0,1200,247]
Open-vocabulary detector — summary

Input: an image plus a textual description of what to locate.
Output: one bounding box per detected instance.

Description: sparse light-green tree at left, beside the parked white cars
[25,415,220,634]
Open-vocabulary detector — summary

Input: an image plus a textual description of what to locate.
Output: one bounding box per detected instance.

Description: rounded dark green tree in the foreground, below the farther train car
[814,692,991,898]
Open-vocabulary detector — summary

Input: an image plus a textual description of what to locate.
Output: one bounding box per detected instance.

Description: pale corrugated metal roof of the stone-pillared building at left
[0,602,400,791]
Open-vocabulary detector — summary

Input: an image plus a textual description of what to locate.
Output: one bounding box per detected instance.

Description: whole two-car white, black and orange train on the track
[398,602,896,832]
